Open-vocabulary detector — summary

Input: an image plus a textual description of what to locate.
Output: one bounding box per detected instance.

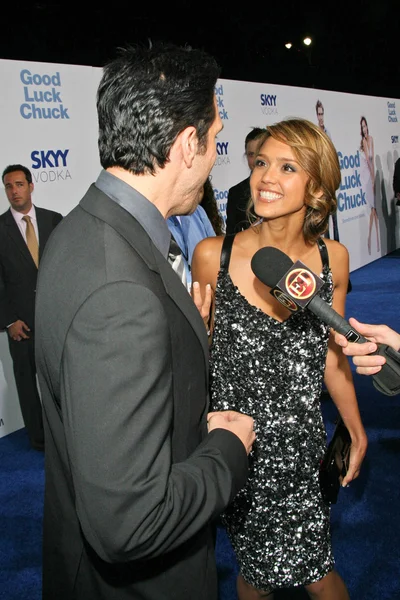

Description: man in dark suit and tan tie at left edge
[0,164,62,450]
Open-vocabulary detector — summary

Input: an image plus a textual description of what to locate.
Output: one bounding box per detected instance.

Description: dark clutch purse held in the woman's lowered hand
[319,417,351,504]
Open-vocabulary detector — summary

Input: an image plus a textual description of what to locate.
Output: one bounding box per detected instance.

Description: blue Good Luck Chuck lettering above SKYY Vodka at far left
[19,69,69,119]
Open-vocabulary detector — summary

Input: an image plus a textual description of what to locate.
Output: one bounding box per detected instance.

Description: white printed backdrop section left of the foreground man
[0,60,100,437]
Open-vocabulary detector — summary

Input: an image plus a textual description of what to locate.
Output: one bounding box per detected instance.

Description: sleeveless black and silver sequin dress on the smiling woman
[211,236,333,590]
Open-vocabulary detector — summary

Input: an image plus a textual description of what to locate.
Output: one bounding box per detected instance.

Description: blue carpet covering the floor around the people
[0,250,400,600]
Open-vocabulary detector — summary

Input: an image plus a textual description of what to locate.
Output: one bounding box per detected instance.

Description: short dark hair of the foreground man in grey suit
[97,43,219,175]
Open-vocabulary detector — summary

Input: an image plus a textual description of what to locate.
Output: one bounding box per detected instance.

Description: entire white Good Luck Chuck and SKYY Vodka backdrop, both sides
[0,60,400,437]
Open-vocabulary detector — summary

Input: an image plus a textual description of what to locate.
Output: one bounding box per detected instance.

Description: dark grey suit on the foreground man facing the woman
[36,185,247,600]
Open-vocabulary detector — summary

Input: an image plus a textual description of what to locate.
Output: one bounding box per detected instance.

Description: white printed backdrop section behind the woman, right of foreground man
[212,80,399,270]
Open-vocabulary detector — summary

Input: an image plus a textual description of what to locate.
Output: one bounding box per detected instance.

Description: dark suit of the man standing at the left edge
[0,207,62,447]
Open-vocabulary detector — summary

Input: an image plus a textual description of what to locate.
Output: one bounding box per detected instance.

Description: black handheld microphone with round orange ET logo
[251,246,400,396]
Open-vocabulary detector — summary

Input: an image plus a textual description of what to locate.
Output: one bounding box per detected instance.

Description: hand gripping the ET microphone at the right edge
[335,318,400,375]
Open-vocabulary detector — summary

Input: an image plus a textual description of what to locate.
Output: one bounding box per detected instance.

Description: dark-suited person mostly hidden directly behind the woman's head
[225,127,265,234]
